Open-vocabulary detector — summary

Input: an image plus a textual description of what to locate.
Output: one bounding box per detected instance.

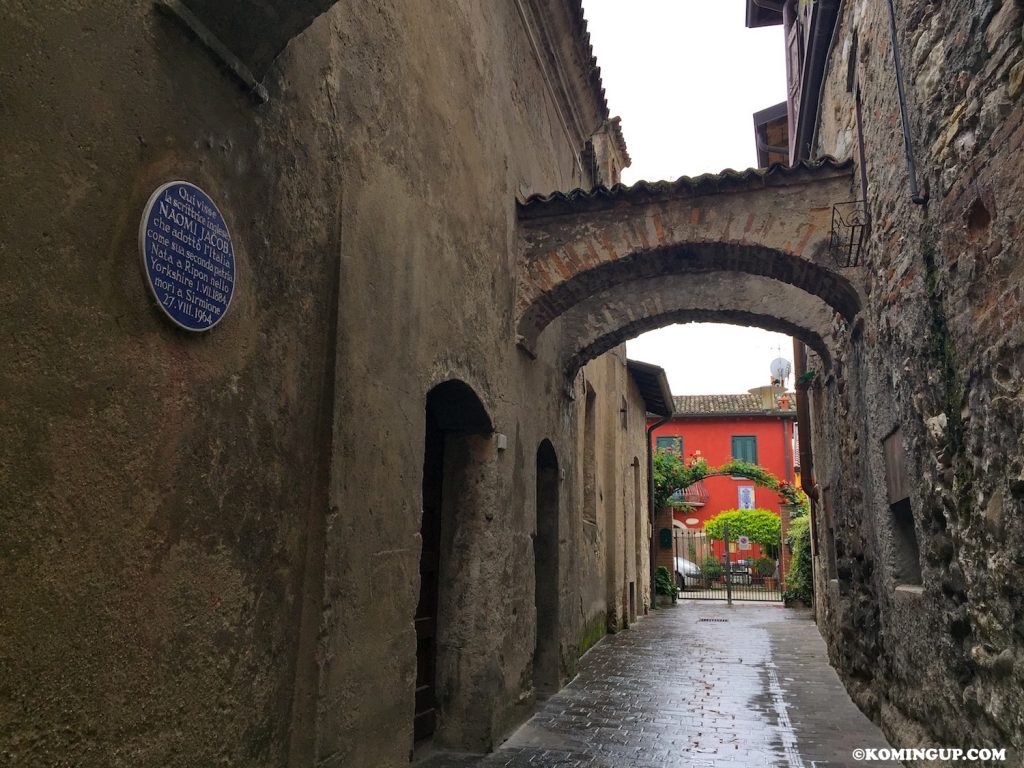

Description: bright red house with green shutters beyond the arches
[651,387,797,557]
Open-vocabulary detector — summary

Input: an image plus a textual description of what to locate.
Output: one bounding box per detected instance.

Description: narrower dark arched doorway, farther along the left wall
[534,440,561,697]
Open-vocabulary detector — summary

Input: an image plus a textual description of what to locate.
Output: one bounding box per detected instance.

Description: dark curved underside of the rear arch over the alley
[564,309,831,379]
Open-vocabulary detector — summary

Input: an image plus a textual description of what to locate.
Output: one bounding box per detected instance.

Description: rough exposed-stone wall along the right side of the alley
[814,0,1024,764]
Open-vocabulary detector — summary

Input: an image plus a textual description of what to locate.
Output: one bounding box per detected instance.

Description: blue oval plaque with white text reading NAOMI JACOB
[138,181,234,331]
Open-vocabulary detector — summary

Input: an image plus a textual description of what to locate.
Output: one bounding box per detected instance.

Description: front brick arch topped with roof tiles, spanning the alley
[516,159,861,354]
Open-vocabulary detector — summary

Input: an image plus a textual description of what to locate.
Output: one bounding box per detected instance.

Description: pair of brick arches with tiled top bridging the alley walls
[516,160,862,375]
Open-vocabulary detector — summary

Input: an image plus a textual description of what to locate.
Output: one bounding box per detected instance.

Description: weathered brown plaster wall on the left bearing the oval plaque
[0,0,649,768]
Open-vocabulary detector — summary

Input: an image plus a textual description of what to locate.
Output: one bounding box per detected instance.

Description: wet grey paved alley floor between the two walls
[423,602,898,768]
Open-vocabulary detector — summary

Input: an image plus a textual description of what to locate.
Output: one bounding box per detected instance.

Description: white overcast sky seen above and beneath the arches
[584,0,793,394]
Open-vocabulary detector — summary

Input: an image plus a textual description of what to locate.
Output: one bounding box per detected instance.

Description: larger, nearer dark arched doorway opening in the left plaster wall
[414,380,494,745]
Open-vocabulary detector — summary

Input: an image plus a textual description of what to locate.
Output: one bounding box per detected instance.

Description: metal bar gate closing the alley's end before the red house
[674,526,785,602]
